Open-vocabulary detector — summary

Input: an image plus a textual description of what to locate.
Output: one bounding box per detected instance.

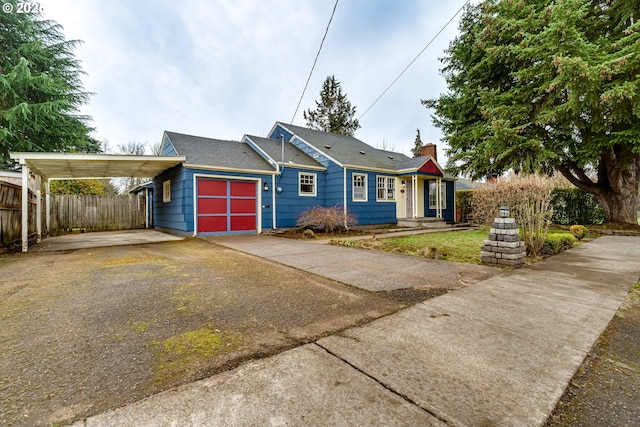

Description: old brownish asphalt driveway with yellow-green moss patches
[0,239,402,425]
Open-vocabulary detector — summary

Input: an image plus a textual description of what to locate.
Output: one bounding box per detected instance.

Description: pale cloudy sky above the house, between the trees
[41,0,465,163]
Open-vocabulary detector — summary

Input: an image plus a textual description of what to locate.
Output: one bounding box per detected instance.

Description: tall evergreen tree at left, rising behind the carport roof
[0,0,99,164]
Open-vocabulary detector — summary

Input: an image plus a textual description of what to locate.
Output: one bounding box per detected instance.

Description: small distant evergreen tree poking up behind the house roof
[303,76,360,136]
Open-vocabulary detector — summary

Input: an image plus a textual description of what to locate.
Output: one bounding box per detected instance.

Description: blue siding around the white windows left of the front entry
[347,169,397,225]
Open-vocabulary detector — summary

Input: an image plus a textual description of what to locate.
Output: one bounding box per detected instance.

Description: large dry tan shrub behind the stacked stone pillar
[472,175,553,256]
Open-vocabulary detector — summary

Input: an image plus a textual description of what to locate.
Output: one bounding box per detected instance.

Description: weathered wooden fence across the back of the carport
[50,194,146,234]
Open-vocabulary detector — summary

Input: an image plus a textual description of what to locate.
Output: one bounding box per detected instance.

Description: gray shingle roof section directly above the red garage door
[165,132,274,172]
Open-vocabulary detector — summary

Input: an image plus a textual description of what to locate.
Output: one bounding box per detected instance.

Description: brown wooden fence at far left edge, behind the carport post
[0,180,36,247]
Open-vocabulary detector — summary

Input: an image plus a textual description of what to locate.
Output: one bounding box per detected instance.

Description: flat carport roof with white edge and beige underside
[9,153,185,179]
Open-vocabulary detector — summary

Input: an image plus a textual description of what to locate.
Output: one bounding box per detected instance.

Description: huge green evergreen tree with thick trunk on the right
[423,0,640,224]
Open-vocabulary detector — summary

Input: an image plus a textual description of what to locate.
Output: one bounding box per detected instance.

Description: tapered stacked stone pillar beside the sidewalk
[480,218,527,267]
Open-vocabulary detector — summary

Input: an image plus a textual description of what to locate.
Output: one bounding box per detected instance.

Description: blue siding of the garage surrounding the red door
[154,165,274,232]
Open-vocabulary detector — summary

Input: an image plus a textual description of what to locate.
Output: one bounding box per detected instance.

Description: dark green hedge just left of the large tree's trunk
[551,188,604,225]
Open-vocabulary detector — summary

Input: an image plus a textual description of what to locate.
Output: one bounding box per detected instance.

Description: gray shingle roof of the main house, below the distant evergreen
[279,122,409,170]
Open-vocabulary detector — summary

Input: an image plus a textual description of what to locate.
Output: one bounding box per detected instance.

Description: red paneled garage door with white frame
[197,178,258,234]
